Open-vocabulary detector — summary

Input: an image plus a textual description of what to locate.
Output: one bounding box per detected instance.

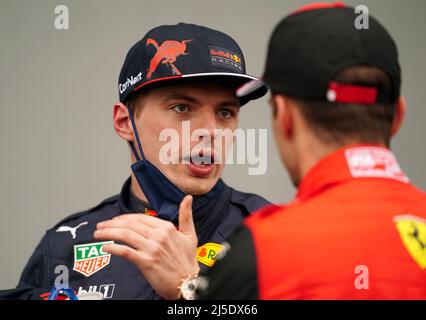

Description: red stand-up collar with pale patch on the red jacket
[296,144,409,201]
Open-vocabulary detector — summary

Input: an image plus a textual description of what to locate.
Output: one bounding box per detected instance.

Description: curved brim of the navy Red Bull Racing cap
[133,72,268,106]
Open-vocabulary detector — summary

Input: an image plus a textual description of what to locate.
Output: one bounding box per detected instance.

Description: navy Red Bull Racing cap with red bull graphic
[118,23,267,105]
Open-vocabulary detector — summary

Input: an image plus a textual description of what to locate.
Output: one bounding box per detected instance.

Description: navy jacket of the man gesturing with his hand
[14,178,269,299]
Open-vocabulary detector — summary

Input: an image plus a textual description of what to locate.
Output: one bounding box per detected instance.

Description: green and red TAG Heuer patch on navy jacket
[73,241,114,277]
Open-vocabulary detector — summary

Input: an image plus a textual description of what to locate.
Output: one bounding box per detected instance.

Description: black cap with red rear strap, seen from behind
[238,2,401,104]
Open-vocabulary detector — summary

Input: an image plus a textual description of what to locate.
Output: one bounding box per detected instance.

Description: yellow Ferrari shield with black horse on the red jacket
[393,215,426,269]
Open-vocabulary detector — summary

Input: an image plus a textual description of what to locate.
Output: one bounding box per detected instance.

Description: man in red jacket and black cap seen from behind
[194,3,426,299]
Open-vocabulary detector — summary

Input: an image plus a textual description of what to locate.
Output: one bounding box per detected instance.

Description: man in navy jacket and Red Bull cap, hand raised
[4,23,268,299]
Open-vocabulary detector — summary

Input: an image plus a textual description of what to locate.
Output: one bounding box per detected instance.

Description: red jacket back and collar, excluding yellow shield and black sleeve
[245,146,426,299]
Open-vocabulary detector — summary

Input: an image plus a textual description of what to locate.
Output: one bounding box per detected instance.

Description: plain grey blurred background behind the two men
[0,0,426,289]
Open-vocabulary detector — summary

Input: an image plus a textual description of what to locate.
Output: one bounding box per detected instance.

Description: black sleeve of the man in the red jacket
[197,225,259,300]
